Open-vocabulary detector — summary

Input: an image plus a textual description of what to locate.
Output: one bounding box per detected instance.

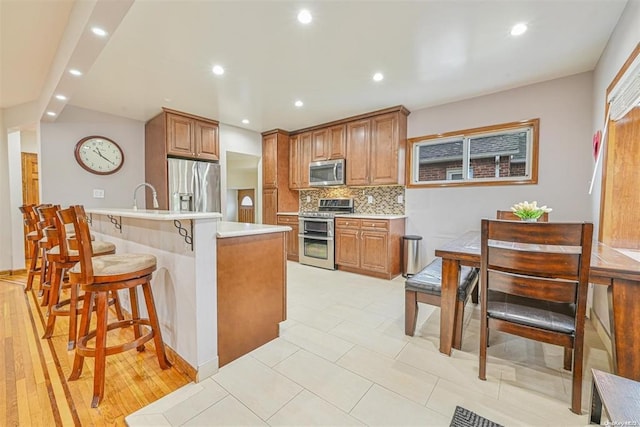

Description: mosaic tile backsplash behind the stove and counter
[300,185,404,215]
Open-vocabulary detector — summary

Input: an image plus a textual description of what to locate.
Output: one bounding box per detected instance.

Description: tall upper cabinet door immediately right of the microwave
[346,119,371,185]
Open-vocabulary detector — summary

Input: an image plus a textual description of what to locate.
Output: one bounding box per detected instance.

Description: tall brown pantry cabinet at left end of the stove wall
[262,129,299,225]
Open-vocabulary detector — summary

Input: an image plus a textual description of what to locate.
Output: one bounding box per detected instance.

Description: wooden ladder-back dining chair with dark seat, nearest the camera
[478,219,593,414]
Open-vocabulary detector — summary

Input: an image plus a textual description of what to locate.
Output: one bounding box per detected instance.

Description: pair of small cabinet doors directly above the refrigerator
[165,109,220,161]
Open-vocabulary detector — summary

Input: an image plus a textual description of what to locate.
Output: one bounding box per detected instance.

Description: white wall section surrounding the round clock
[40,106,144,208]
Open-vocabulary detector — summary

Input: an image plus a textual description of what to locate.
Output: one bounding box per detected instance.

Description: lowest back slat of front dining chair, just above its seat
[488,271,577,303]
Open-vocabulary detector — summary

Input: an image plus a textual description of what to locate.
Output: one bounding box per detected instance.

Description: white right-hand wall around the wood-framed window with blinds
[590,1,640,331]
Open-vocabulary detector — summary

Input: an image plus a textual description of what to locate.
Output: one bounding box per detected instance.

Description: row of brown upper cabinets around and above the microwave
[289,106,409,190]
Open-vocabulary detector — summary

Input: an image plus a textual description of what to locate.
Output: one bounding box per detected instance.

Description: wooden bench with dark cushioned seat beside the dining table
[404,257,479,349]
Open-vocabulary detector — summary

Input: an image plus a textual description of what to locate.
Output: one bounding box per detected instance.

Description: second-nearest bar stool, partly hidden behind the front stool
[42,210,124,350]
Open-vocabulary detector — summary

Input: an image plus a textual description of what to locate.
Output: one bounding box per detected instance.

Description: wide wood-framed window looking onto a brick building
[407,119,539,187]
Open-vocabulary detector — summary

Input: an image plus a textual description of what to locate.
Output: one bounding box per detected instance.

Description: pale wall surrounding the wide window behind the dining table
[405,72,594,263]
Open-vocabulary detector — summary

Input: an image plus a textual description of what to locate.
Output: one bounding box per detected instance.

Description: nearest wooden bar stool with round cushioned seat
[67,206,171,408]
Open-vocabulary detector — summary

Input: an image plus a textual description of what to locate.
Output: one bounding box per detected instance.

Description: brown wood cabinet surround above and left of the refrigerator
[144,108,219,209]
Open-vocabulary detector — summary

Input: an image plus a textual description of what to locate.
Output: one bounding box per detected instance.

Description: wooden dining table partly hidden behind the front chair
[435,231,640,381]
